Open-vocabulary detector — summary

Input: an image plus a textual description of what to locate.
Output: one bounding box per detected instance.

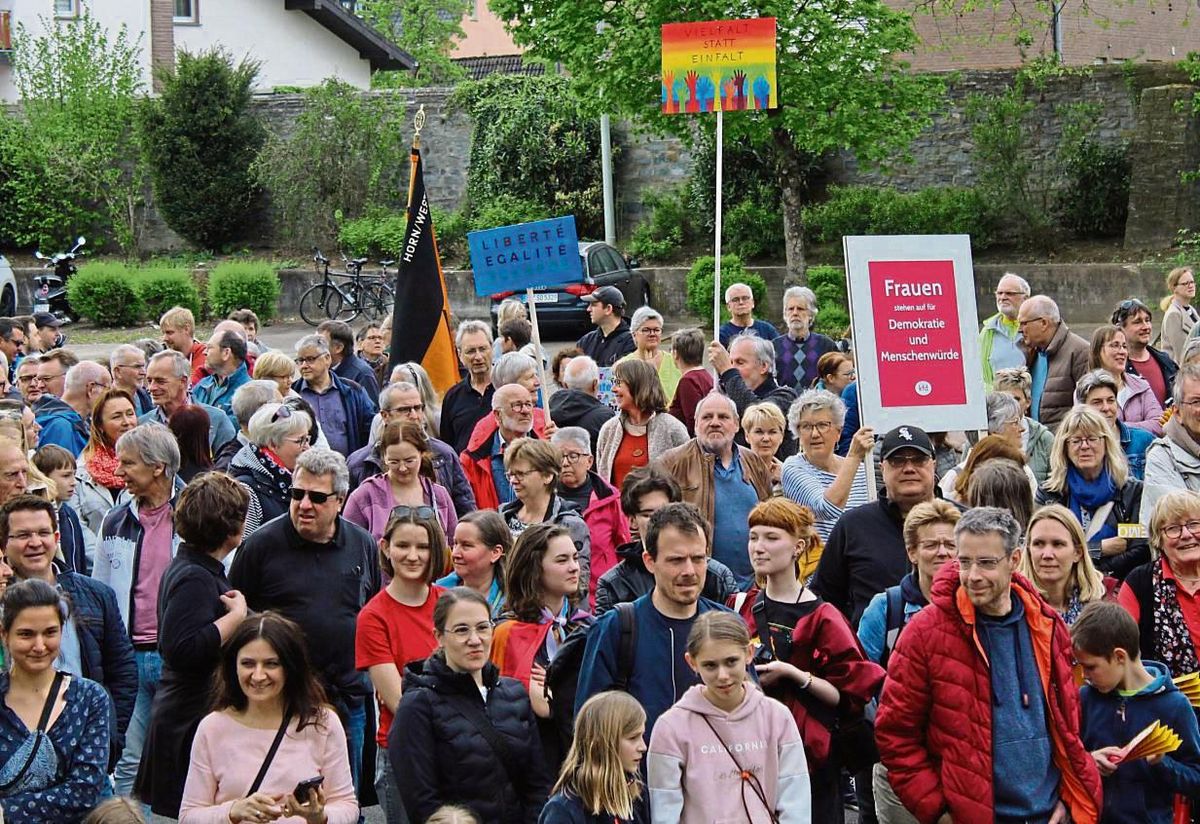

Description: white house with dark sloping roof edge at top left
[0,0,416,102]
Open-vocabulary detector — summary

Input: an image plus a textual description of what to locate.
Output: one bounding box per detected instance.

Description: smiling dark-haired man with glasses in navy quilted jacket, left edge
[0,494,138,763]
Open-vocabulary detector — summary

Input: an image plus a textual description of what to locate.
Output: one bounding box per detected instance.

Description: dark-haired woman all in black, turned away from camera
[136,473,250,818]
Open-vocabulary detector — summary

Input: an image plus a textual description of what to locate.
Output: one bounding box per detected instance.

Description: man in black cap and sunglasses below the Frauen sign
[812,426,960,627]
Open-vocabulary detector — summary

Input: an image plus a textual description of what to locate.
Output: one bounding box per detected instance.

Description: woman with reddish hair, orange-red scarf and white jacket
[70,389,138,535]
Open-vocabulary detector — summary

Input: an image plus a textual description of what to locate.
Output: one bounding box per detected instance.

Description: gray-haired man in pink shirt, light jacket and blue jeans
[92,422,182,794]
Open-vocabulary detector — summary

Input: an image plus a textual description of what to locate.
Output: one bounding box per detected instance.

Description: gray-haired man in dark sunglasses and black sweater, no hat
[229,449,382,801]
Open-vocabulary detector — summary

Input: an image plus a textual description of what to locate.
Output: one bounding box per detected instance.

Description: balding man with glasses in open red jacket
[458,384,546,510]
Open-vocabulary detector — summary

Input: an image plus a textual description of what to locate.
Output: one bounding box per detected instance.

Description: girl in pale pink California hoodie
[647,612,811,824]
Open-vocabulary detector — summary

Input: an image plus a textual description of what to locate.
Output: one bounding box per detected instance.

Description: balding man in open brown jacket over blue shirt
[658,392,772,591]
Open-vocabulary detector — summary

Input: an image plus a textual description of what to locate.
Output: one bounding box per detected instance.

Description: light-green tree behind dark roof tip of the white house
[356,0,474,88]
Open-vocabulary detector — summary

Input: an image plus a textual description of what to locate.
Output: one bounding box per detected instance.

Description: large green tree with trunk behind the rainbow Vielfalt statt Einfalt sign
[491,0,943,281]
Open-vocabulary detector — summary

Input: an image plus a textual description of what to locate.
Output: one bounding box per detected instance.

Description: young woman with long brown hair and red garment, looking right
[492,523,593,772]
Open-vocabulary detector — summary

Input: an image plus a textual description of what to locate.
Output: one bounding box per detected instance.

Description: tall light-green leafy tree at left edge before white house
[0,14,143,253]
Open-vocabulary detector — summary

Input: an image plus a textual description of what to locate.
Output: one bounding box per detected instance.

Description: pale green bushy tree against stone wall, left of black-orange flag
[252,79,408,243]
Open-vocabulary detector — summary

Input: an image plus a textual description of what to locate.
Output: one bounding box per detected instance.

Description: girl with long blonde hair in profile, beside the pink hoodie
[538,691,649,824]
